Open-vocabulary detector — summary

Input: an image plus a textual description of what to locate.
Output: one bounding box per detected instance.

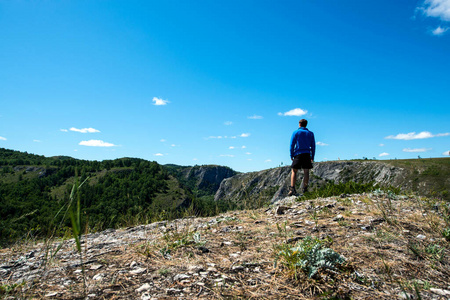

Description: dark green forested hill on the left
[0,148,239,245]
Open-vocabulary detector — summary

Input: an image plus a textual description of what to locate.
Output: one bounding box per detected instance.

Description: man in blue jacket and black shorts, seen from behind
[288,119,316,196]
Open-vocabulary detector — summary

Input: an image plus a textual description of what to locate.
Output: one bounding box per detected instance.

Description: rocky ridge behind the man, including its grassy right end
[215,158,450,203]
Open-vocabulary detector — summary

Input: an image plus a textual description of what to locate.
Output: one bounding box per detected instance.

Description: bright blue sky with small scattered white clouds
[0,0,450,172]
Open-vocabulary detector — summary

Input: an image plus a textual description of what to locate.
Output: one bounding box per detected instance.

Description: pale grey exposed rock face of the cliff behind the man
[215,161,424,203]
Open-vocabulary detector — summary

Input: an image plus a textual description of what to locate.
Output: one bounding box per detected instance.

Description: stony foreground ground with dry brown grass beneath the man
[0,192,450,299]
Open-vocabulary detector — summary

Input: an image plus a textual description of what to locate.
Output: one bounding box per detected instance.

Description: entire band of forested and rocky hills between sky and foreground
[0,148,450,245]
